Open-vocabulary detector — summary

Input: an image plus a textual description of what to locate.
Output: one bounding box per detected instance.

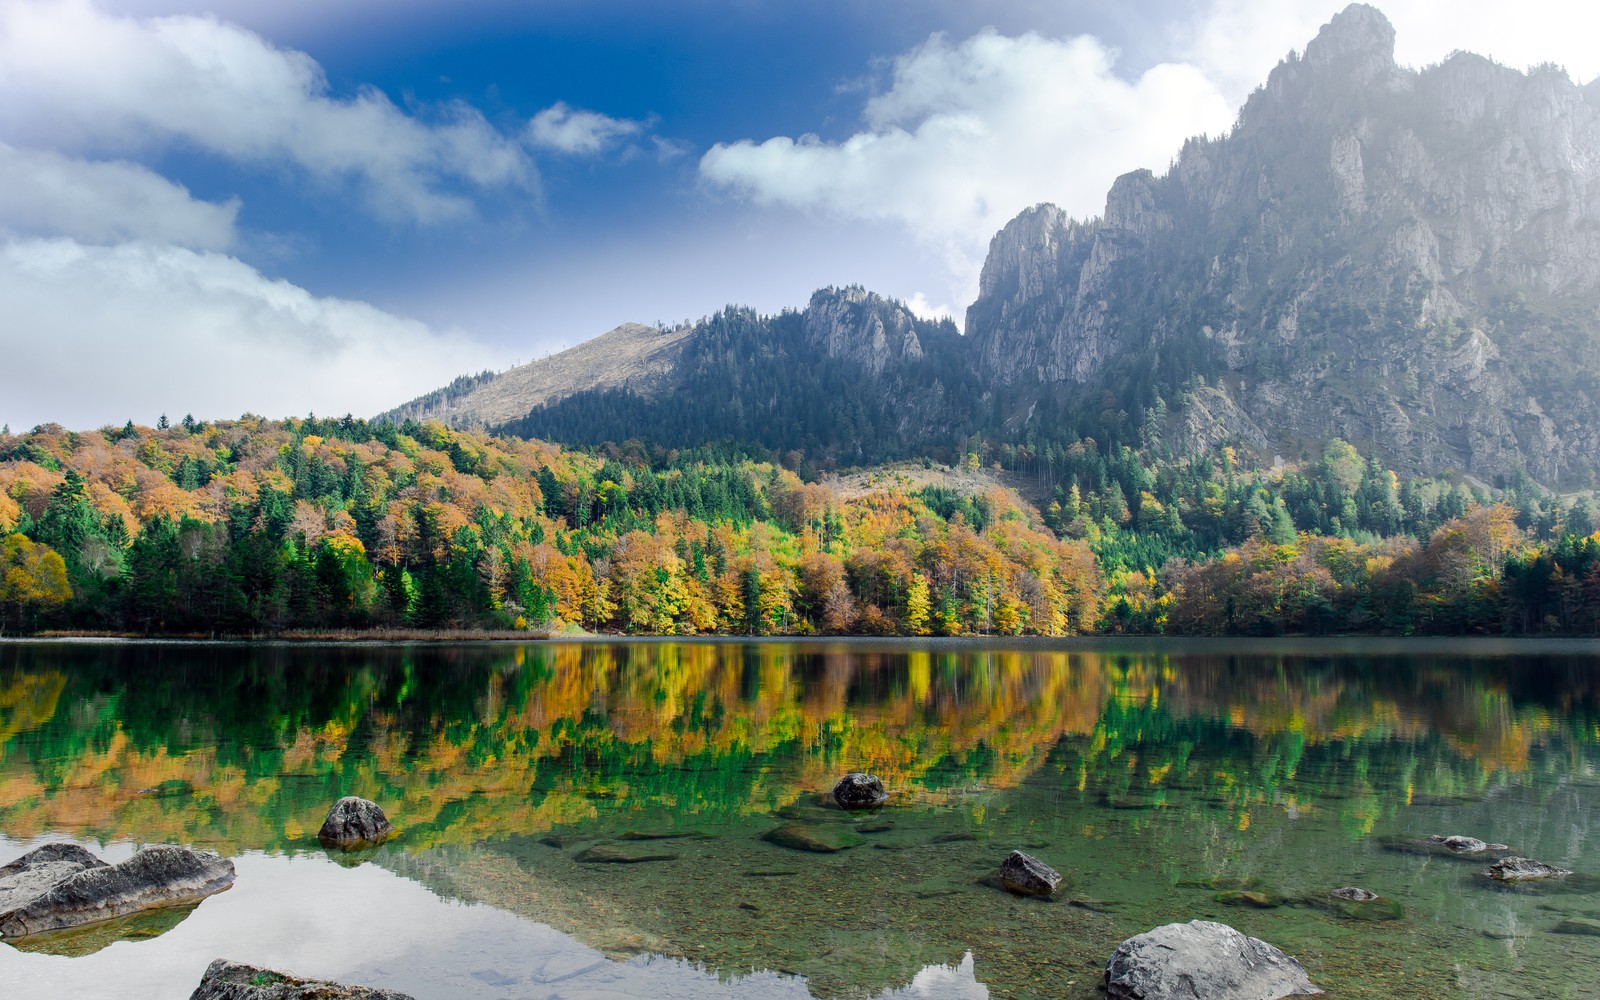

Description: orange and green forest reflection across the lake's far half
[0,642,1600,850]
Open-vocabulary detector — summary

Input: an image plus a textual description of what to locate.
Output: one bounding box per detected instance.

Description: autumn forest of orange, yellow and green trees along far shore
[0,414,1600,635]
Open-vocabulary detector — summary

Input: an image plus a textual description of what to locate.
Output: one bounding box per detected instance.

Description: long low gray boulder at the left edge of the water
[0,845,234,938]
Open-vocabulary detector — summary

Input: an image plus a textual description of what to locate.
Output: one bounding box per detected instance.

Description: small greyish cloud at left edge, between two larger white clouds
[0,142,238,250]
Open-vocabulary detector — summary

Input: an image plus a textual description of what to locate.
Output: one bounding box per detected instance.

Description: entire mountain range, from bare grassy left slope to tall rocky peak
[387,5,1600,486]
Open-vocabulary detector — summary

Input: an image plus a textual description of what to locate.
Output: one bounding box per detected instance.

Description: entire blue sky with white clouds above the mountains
[0,0,1600,429]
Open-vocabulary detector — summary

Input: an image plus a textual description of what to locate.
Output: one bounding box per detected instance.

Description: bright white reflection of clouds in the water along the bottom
[0,837,989,1000]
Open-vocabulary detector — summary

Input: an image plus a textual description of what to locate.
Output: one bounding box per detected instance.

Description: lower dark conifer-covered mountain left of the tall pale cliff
[501,286,984,462]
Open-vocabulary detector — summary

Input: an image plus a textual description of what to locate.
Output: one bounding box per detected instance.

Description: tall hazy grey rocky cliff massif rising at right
[966,5,1600,483]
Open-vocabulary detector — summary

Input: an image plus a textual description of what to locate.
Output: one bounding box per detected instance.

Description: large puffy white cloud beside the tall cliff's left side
[701,30,1235,301]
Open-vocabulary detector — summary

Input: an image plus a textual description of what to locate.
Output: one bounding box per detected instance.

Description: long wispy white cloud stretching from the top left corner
[0,0,538,222]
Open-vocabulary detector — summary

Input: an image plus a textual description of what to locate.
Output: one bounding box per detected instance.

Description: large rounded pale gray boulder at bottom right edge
[1106,920,1322,1000]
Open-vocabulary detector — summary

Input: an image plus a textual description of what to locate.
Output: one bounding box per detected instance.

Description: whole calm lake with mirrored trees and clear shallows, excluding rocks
[0,640,1600,1000]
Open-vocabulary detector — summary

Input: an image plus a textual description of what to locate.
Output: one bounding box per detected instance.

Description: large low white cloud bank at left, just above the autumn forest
[0,238,494,429]
